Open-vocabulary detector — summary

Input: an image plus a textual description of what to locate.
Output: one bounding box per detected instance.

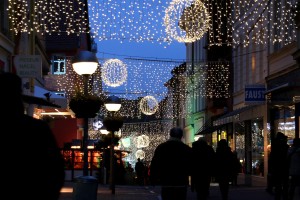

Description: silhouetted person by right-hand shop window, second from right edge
[270,132,289,200]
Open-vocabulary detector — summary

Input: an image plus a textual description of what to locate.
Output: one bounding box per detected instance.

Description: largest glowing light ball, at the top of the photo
[164,0,210,43]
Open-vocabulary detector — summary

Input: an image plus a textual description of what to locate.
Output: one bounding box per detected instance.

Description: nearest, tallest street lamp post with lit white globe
[72,51,98,176]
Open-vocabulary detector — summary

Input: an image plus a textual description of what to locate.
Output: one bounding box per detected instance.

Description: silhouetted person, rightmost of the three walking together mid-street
[216,139,235,200]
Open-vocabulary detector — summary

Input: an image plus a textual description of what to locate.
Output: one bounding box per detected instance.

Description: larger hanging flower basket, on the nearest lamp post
[69,93,103,118]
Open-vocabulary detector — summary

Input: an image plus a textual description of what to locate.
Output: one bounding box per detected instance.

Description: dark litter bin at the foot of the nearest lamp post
[72,176,98,200]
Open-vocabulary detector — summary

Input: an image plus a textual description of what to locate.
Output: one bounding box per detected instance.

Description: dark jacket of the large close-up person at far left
[2,115,65,200]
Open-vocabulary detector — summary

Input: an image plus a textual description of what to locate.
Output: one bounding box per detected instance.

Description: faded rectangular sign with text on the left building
[13,55,42,78]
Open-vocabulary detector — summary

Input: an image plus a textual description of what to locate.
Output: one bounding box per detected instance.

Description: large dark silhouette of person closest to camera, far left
[0,72,65,200]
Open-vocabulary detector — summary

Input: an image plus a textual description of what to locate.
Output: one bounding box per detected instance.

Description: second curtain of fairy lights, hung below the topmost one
[53,54,229,119]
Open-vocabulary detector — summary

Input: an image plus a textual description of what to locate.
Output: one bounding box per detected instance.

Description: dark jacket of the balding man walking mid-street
[150,138,192,186]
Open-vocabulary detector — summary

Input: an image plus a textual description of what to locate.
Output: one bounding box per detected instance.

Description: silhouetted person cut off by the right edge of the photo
[288,138,300,200]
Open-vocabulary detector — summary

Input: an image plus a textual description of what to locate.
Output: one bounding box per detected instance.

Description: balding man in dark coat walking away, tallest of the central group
[150,127,192,200]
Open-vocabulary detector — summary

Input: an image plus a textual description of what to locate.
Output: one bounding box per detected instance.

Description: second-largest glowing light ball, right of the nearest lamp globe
[101,59,127,87]
